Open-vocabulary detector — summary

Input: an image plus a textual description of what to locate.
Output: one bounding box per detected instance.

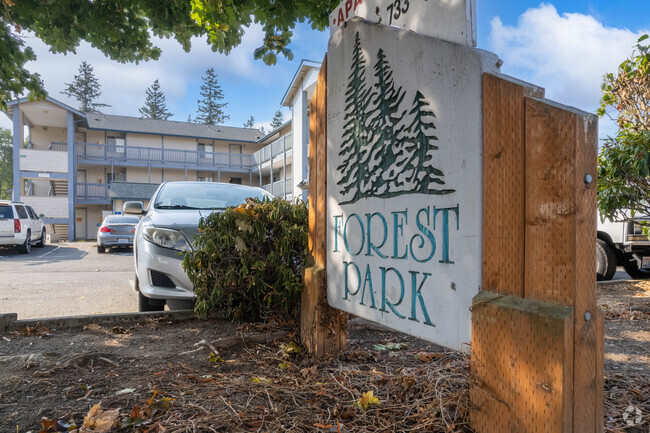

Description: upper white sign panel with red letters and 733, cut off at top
[330,0,476,47]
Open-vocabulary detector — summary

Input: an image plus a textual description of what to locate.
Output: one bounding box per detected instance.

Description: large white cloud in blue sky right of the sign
[490,4,645,137]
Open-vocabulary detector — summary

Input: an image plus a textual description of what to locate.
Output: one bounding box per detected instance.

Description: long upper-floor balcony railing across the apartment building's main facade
[50,142,257,170]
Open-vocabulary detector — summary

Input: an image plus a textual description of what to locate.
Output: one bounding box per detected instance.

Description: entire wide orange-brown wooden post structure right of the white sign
[471,74,604,433]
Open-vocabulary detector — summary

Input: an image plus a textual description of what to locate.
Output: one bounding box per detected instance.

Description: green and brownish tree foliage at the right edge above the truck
[598,35,650,221]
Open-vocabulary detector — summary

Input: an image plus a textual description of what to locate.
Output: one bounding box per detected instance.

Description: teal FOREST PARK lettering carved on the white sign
[332,205,460,326]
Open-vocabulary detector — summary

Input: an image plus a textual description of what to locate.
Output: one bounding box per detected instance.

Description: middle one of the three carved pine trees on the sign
[369,49,406,196]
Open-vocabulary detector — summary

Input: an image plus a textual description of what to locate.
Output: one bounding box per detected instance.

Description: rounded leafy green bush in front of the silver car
[183,198,308,320]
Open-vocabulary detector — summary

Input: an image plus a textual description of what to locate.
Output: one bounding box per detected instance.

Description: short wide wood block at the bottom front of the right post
[471,291,573,433]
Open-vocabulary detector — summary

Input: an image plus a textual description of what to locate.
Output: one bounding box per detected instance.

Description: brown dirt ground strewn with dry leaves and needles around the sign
[0,282,650,433]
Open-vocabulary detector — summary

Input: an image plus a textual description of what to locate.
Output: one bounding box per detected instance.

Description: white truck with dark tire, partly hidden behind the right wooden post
[596,218,650,281]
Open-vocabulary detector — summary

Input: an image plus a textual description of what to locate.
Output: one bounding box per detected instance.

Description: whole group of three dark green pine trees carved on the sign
[336,36,456,205]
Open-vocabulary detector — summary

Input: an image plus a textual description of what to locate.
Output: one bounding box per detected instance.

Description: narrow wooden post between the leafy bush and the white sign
[300,56,348,356]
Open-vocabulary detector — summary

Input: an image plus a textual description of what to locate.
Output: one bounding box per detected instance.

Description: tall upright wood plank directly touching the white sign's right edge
[482,74,526,296]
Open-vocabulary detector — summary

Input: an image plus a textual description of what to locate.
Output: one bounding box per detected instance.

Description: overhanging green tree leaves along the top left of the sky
[0,0,339,108]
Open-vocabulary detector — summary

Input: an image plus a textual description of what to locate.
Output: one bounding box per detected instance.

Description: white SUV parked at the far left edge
[0,200,45,254]
